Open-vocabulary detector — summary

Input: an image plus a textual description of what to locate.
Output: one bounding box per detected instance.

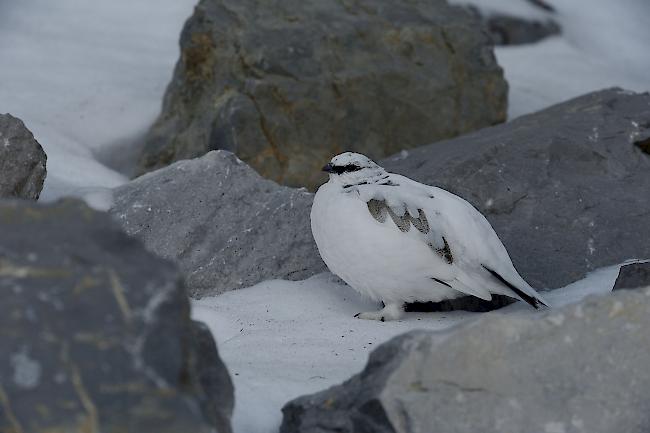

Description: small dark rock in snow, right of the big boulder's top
[484,15,561,45]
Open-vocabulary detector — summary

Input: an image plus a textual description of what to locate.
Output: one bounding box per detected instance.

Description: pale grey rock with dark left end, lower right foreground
[280,289,650,433]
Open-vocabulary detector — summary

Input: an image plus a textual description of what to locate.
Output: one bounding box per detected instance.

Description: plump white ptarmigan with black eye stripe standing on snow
[310,152,549,322]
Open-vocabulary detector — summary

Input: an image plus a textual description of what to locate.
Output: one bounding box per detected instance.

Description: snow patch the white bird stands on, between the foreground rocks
[192,266,620,433]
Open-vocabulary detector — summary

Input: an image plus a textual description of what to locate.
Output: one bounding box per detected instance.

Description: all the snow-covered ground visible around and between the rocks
[0,0,650,433]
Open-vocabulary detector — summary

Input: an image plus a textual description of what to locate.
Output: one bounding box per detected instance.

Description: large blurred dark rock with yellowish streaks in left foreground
[0,200,233,433]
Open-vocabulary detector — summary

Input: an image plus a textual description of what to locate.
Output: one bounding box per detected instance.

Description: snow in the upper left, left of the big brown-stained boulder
[0,0,195,201]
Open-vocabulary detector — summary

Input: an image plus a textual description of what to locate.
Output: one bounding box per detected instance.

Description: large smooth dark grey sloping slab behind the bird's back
[382,89,650,288]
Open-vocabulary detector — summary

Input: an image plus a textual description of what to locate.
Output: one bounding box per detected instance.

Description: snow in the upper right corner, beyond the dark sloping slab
[452,0,650,119]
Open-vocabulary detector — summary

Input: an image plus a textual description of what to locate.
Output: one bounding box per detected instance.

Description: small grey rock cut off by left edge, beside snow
[0,114,47,200]
